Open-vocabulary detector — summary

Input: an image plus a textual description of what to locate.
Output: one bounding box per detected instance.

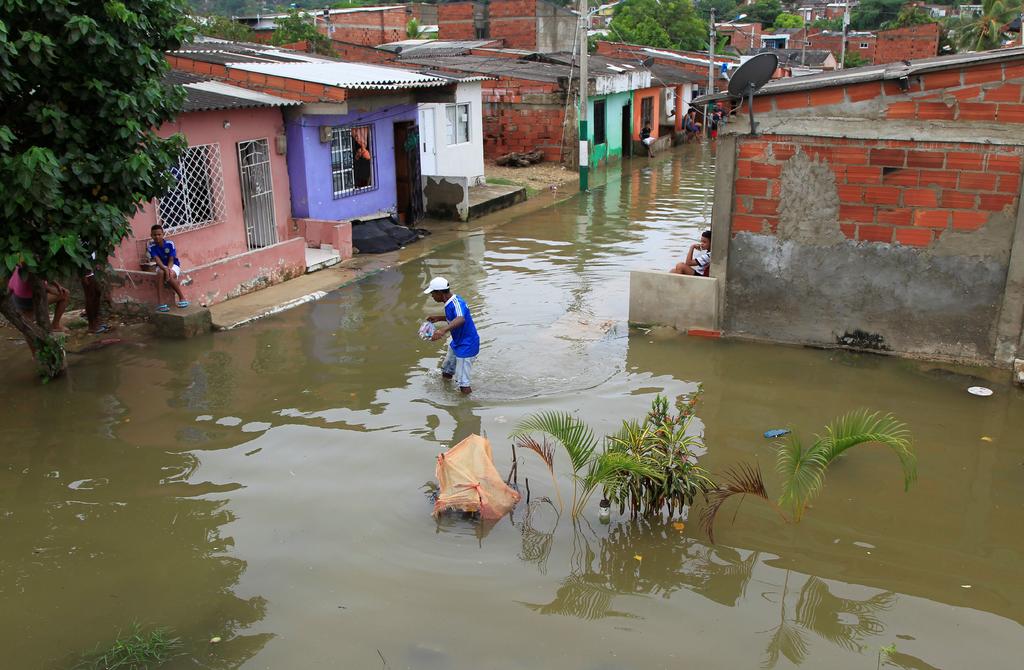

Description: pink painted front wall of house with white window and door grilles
[111,108,304,303]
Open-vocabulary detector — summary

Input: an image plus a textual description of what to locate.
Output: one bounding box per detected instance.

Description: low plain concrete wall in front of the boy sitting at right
[630,270,719,331]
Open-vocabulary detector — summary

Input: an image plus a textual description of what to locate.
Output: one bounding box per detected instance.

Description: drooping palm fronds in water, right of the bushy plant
[700,410,918,542]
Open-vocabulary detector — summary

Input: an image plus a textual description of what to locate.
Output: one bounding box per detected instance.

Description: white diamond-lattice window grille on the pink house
[157,144,224,233]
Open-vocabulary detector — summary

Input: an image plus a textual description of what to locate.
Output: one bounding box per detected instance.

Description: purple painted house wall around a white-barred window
[285,104,416,221]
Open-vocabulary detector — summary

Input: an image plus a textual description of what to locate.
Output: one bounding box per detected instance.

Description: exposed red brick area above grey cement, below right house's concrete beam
[732,135,1024,247]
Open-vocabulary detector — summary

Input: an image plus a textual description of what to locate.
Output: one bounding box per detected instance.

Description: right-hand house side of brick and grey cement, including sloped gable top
[712,49,1024,365]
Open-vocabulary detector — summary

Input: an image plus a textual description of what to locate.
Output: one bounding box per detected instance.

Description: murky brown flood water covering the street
[0,146,1024,670]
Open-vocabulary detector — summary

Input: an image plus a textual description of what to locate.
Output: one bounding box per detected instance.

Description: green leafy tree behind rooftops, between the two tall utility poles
[611,0,708,50]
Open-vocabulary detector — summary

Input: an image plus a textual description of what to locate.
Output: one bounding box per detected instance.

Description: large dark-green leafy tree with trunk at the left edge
[0,0,188,377]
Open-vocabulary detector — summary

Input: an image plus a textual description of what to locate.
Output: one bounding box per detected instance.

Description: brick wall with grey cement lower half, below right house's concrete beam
[717,135,1024,364]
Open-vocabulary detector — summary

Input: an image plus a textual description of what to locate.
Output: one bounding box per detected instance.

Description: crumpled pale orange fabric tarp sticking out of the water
[434,435,519,519]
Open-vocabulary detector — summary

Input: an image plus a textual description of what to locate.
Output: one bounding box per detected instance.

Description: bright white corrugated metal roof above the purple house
[231,60,451,90]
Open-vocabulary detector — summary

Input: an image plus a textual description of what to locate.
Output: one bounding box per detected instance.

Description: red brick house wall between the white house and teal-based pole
[482,78,565,163]
